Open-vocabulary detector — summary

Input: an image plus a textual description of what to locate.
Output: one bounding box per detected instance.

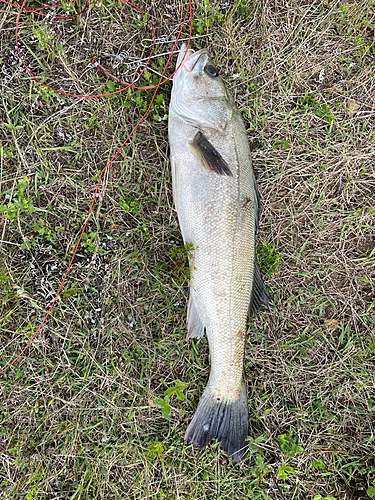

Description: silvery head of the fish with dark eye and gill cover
[170,44,234,131]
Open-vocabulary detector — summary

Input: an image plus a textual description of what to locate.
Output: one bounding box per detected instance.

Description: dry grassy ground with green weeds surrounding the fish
[0,0,375,500]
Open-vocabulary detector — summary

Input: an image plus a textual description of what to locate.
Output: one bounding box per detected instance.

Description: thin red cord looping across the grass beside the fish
[0,0,192,374]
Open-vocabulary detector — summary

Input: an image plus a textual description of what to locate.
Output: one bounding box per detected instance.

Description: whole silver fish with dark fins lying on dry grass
[168,44,268,462]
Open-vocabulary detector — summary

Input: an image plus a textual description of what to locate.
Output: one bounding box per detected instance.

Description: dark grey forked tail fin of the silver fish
[185,381,249,462]
